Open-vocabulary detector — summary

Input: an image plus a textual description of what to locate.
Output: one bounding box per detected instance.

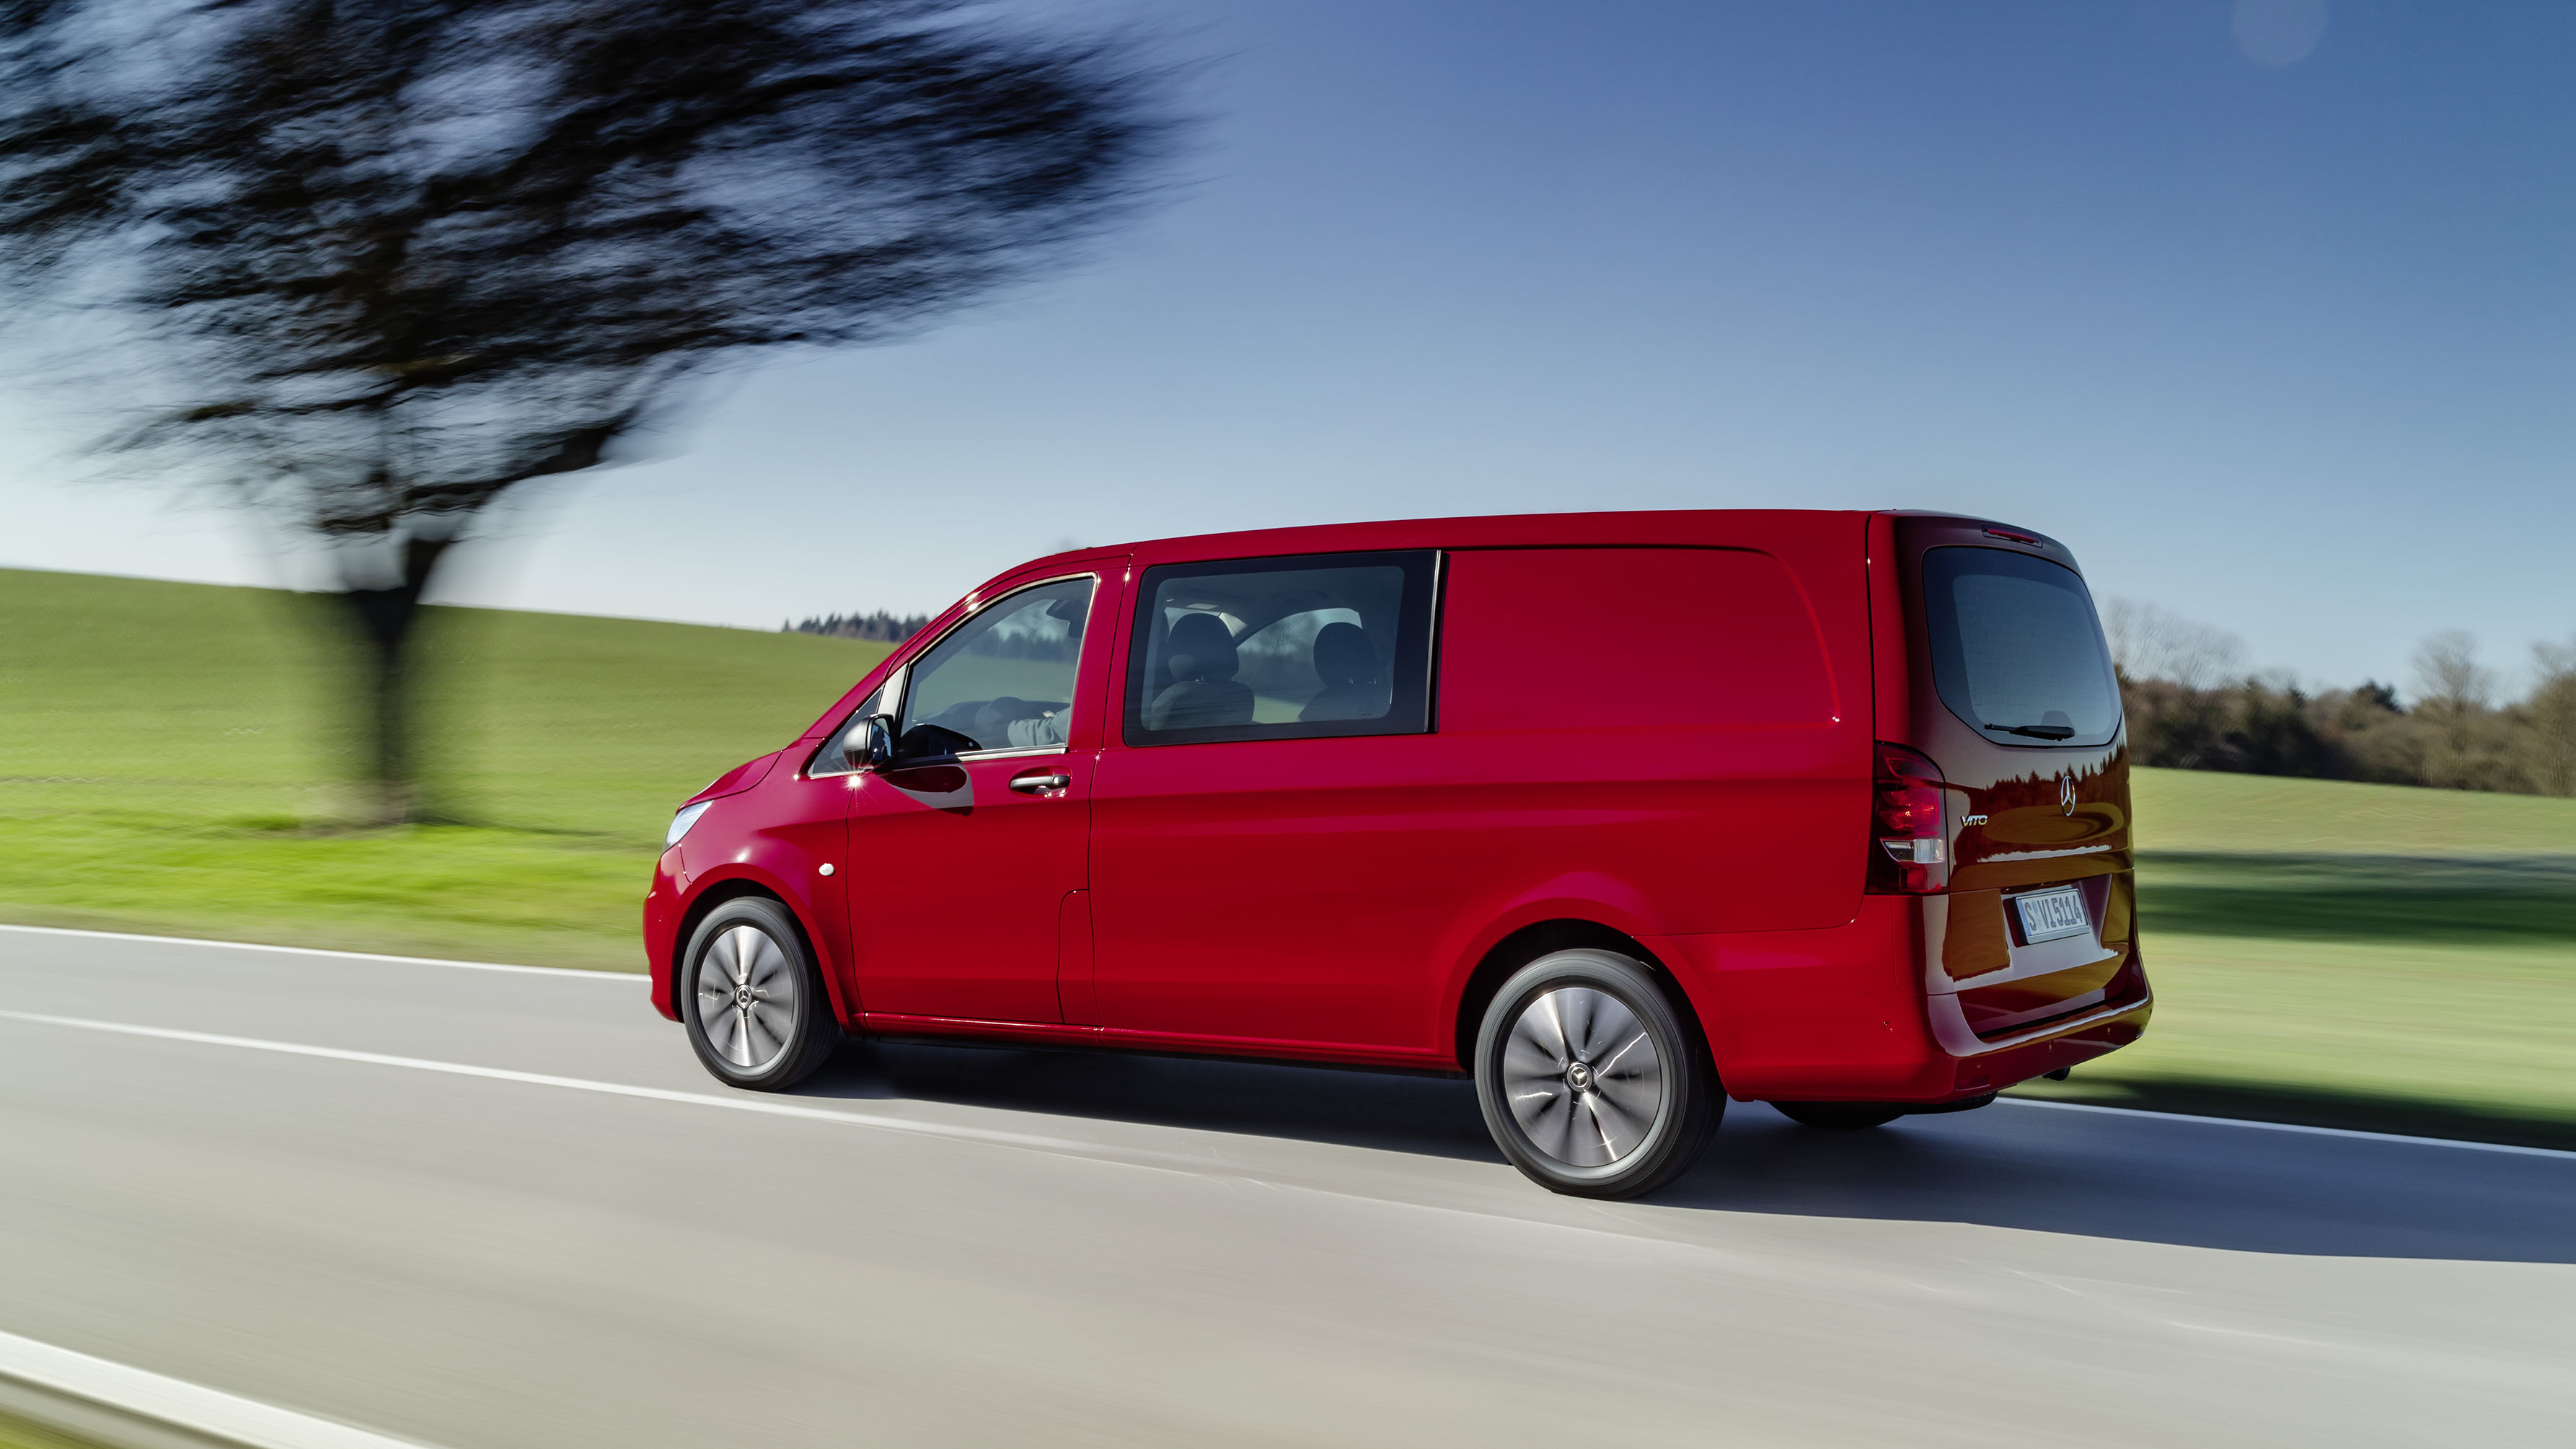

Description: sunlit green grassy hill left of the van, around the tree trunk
[0,570,886,969]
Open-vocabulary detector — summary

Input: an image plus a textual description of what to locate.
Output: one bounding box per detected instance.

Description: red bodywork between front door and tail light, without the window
[1093,516,1868,1065]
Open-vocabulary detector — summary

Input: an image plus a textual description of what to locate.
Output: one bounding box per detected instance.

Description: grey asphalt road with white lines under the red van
[0,930,2576,1449]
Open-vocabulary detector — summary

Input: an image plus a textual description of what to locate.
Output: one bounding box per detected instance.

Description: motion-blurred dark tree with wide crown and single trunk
[0,0,1172,820]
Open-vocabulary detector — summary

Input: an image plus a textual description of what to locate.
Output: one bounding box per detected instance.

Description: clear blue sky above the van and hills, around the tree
[0,0,2576,701]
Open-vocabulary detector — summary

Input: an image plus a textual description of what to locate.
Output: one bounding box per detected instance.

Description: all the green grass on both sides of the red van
[0,570,2576,1148]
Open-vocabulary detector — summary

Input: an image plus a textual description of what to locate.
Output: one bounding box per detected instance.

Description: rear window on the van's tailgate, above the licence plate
[1924,547,2120,745]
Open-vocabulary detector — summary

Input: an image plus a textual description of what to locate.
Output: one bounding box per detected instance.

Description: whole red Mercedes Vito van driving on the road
[644,511,2151,1197]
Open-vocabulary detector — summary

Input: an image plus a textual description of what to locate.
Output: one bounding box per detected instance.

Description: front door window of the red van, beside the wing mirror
[896,578,1098,755]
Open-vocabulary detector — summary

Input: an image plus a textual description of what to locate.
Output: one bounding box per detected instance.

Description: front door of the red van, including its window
[850,573,1108,1021]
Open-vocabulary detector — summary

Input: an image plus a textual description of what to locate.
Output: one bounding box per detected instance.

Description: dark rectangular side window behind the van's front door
[1123,552,1440,745]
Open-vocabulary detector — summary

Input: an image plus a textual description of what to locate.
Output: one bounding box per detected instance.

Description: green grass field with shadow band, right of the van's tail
[2019,771,2576,1148]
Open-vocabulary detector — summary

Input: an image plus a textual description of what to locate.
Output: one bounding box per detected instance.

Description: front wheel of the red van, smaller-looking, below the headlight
[680,897,839,1091]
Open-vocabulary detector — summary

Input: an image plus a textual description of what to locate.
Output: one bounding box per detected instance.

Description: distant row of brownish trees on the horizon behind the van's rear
[2104,601,2576,794]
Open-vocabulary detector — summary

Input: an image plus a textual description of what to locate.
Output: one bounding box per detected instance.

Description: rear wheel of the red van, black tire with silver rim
[1476,949,1726,1199]
